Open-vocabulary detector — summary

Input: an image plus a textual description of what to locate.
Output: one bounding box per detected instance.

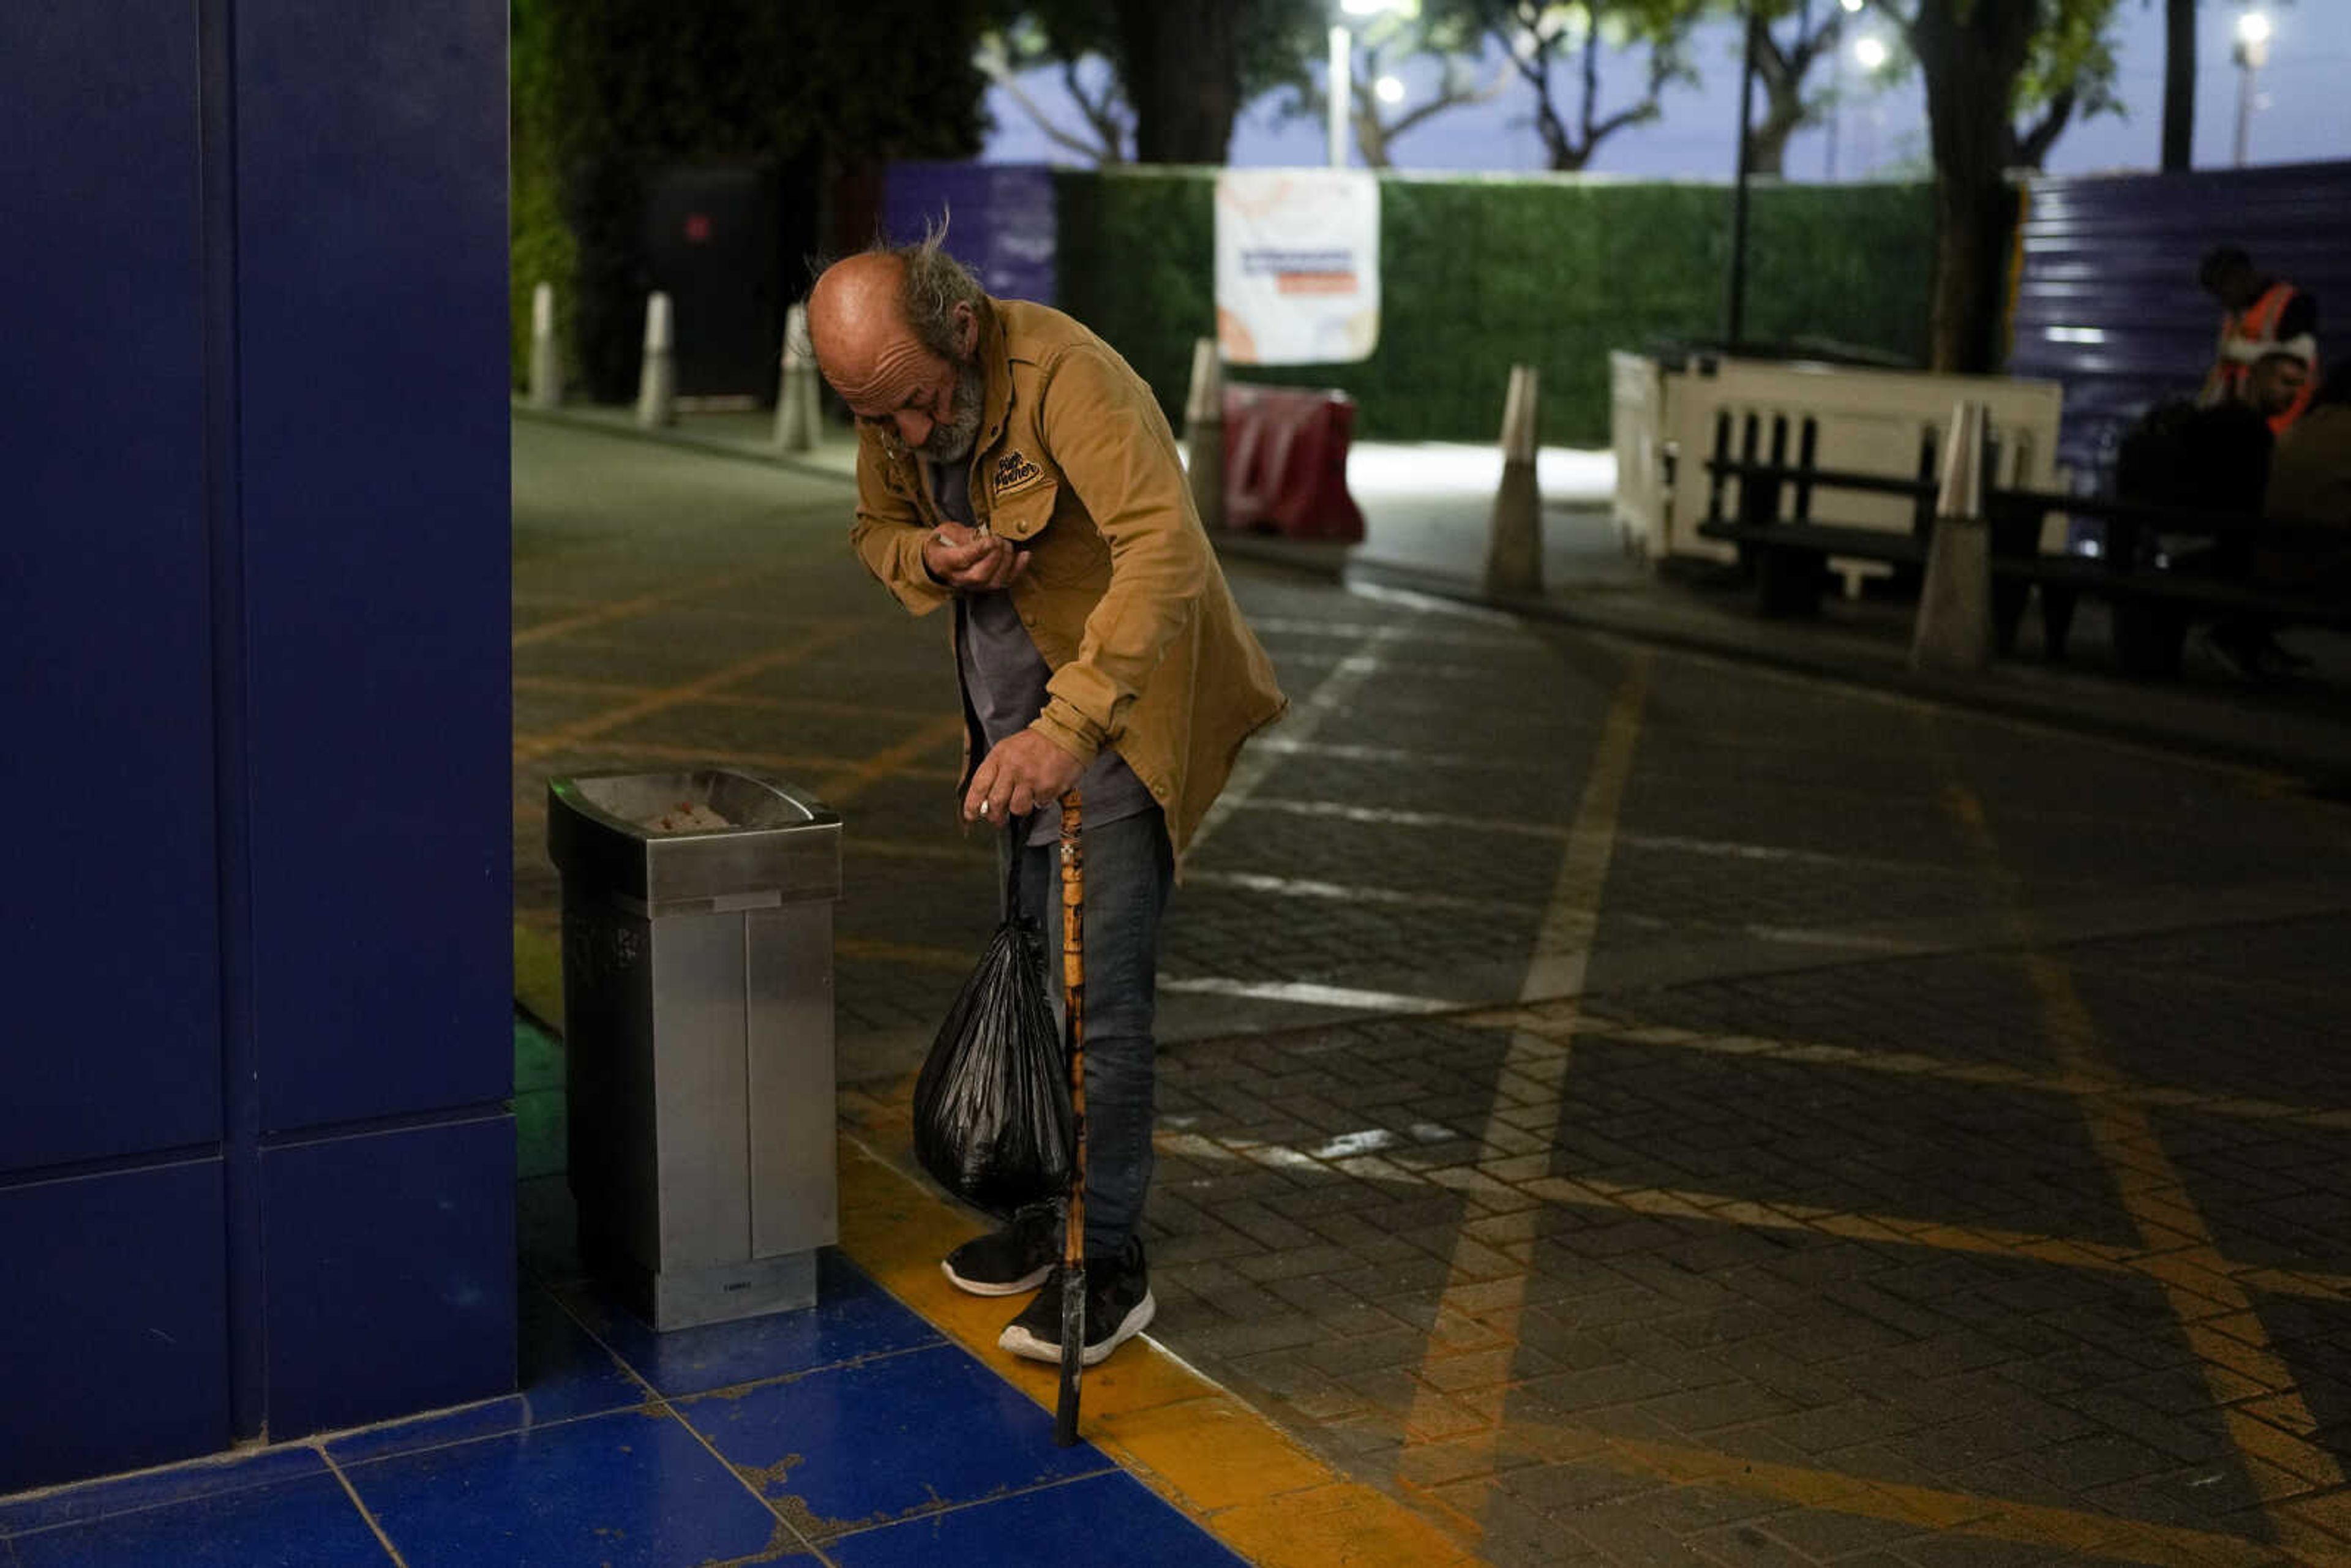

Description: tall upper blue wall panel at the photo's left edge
[0,0,221,1173]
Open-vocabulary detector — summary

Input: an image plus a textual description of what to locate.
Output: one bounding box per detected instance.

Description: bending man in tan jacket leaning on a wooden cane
[809,235,1284,1364]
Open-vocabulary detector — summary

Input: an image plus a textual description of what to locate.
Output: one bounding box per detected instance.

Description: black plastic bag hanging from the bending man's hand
[915,823,1074,1215]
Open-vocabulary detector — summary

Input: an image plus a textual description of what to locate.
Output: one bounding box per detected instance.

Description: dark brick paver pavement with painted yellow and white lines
[515,426,2351,1568]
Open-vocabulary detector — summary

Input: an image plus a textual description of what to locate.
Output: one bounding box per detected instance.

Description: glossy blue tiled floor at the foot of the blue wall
[0,1253,1239,1568]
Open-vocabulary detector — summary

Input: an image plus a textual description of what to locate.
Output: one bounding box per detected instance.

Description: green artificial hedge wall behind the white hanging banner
[1058,169,1935,447]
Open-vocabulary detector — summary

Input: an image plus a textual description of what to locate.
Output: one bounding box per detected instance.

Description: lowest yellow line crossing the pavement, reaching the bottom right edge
[1502,1422,2278,1568]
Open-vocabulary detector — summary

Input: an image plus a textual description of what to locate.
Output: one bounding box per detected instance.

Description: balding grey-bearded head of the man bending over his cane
[809,242,988,461]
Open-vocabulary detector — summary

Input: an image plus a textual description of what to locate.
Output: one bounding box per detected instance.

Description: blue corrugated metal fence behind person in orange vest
[2008,162,2351,482]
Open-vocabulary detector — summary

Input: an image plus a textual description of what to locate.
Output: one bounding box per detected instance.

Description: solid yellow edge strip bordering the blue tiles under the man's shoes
[842,1133,1479,1568]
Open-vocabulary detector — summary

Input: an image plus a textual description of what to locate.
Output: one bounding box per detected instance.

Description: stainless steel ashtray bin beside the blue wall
[548,769,842,1328]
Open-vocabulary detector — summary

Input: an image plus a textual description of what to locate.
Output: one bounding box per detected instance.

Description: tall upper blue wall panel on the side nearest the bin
[235,0,512,1133]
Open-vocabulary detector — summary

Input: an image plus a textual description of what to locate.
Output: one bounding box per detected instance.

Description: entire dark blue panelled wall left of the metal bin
[0,0,515,1493]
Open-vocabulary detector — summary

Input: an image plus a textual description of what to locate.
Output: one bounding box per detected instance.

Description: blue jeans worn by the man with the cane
[999,806,1176,1258]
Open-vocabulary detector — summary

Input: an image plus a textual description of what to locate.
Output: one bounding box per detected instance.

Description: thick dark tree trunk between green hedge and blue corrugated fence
[1911,0,2038,373]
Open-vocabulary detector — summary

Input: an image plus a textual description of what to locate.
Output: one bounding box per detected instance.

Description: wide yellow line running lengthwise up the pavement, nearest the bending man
[1373,651,1653,1540]
